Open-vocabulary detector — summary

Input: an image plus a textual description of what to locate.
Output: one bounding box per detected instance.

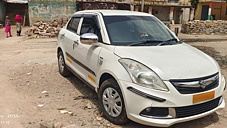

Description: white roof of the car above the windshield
[74,10,151,16]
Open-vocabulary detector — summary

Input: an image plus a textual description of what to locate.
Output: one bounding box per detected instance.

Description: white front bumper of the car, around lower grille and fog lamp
[118,77,225,127]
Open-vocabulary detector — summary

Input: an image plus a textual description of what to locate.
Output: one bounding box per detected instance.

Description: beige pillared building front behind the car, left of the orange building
[134,0,194,24]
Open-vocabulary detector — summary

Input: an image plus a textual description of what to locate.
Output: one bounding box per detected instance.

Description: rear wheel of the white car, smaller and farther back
[58,51,71,77]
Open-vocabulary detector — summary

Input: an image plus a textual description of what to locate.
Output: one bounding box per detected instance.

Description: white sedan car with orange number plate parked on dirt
[57,10,225,127]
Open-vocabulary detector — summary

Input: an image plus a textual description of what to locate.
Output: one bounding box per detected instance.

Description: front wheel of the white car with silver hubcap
[98,79,129,124]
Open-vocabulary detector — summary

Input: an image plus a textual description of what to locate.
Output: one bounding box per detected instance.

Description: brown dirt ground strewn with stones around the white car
[0,27,227,128]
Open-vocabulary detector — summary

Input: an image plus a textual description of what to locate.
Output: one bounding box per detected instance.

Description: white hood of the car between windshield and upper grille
[114,43,219,80]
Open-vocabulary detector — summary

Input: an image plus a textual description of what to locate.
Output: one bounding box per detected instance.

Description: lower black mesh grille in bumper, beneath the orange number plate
[175,97,221,118]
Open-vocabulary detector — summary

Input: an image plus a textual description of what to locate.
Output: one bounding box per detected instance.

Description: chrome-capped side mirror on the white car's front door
[80,33,98,45]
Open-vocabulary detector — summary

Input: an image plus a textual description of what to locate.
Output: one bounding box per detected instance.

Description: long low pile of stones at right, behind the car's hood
[181,20,227,34]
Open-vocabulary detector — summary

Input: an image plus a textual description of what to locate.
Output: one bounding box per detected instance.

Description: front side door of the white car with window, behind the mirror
[72,14,102,87]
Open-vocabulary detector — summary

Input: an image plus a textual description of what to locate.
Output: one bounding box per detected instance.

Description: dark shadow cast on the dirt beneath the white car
[67,75,219,128]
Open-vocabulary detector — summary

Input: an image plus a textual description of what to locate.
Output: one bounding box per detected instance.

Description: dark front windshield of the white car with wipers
[104,16,180,46]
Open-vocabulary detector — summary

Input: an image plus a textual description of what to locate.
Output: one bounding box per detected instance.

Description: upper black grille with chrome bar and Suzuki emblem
[170,73,219,94]
